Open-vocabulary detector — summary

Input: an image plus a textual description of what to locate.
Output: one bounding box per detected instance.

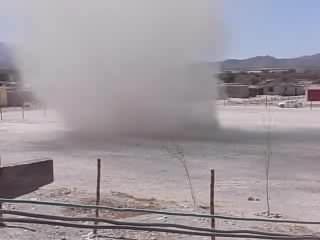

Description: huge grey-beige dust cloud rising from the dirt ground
[13,0,221,137]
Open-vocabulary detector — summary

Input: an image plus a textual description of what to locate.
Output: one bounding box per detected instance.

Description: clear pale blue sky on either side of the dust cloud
[0,0,320,58]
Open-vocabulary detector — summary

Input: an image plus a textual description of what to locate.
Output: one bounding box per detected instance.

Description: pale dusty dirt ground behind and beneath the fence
[0,105,320,240]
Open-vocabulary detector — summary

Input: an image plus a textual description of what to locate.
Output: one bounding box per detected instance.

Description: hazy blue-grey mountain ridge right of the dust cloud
[221,54,320,70]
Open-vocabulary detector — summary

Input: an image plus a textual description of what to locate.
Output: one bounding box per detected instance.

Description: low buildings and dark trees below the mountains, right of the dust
[218,68,320,99]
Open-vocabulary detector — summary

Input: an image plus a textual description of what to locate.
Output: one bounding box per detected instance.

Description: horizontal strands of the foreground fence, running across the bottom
[0,198,320,239]
